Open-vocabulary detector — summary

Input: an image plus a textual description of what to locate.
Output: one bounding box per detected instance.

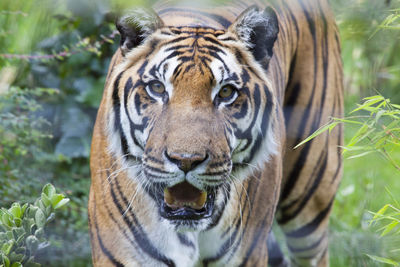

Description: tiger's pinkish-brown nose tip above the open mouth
[165,151,208,173]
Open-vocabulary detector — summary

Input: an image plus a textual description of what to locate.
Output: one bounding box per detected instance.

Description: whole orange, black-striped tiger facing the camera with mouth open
[88,0,343,267]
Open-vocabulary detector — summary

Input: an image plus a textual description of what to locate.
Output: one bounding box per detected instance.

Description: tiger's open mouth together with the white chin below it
[160,182,215,232]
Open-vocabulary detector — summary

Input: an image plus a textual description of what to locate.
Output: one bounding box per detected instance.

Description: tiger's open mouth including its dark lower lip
[161,182,215,220]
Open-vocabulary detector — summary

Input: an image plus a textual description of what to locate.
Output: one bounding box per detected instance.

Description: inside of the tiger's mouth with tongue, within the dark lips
[164,182,207,210]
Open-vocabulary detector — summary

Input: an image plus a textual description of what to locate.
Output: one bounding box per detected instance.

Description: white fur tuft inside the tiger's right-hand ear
[230,7,268,47]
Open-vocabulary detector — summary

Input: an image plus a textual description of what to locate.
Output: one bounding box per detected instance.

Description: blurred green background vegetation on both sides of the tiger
[0,0,400,266]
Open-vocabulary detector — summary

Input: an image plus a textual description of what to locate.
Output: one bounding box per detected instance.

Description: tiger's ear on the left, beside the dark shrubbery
[116,9,164,56]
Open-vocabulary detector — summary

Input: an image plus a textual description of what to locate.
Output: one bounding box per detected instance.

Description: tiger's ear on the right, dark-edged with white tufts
[228,5,279,64]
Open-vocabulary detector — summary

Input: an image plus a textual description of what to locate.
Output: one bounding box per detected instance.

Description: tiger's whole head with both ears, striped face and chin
[107,7,278,231]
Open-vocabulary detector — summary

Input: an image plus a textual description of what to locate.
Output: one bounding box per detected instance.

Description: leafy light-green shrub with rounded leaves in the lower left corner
[0,184,69,267]
